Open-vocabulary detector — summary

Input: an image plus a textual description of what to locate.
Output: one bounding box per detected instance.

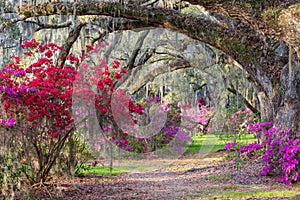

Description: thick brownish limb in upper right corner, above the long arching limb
[186,0,300,46]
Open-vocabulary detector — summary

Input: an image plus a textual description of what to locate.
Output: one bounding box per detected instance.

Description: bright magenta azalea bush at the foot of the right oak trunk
[224,122,300,185]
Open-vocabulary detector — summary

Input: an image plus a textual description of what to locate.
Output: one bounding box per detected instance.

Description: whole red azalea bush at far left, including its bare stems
[0,39,79,184]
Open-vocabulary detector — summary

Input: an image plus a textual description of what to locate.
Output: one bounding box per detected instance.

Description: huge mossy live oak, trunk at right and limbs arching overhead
[0,0,300,134]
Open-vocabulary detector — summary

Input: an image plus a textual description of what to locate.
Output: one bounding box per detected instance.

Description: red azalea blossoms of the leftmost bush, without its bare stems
[5,42,77,138]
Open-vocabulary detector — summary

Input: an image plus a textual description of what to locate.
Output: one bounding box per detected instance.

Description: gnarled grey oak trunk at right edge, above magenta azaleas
[257,50,300,136]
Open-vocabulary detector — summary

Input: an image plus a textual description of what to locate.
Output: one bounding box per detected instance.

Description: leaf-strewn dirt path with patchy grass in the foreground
[12,153,300,200]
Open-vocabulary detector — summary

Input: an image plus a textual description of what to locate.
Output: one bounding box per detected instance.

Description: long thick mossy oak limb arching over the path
[18,2,287,93]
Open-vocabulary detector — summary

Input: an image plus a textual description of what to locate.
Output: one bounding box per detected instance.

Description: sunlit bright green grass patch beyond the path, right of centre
[186,133,255,153]
